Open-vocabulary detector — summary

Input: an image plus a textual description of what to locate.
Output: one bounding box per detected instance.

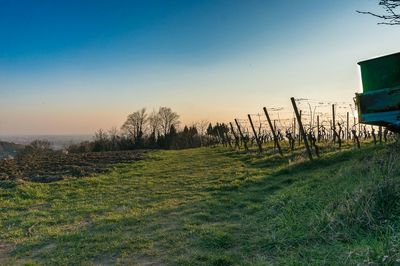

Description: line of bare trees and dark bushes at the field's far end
[68,107,229,152]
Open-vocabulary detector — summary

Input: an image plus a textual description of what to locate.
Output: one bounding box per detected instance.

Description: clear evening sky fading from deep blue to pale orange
[0,0,400,135]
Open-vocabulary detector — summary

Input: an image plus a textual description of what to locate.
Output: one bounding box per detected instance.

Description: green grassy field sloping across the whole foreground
[0,146,400,265]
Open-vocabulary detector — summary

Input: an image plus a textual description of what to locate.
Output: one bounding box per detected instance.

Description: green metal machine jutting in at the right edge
[356,53,400,132]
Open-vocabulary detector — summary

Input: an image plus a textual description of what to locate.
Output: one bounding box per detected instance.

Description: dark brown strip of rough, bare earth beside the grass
[0,151,145,182]
